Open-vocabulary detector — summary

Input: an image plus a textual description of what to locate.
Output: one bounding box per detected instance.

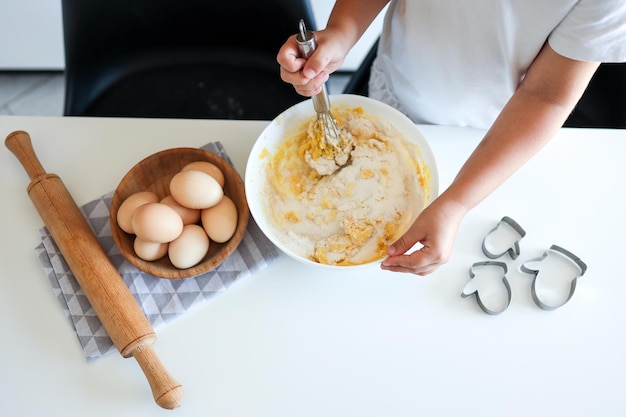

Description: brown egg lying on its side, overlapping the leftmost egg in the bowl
[131,203,183,243]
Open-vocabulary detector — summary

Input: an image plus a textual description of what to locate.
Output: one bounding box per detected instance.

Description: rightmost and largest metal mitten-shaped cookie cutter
[520,245,587,310]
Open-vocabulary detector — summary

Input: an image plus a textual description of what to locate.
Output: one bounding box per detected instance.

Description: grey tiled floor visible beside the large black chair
[0,71,349,116]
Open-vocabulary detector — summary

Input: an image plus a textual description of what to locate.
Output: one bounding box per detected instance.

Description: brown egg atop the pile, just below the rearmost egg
[170,170,224,209]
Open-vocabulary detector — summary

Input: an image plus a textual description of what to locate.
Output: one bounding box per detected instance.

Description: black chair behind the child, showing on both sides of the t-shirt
[343,40,626,129]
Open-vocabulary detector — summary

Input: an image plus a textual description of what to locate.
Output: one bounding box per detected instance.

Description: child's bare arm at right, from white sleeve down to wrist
[444,45,598,210]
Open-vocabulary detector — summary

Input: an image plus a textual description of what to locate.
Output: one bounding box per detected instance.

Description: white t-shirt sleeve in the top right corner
[548,0,626,62]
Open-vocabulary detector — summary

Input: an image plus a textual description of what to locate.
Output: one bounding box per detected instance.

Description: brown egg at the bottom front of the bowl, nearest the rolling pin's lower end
[167,224,209,269]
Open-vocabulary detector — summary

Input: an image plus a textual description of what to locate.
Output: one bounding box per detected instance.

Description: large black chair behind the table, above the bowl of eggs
[62,0,316,120]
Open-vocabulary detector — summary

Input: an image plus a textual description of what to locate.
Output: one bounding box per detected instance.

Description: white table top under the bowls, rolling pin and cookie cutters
[0,117,626,417]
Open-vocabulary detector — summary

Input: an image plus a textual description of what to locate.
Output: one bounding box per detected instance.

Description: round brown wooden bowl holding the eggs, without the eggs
[110,148,250,279]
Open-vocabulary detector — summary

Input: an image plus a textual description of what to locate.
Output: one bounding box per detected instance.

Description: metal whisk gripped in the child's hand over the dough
[296,20,341,149]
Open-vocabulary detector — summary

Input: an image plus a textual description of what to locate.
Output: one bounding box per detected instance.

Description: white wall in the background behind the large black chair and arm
[0,0,382,71]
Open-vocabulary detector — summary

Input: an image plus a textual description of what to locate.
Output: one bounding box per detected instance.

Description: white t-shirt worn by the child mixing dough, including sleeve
[370,0,626,128]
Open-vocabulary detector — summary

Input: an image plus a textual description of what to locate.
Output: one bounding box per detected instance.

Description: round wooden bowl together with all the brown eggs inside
[109,148,250,279]
